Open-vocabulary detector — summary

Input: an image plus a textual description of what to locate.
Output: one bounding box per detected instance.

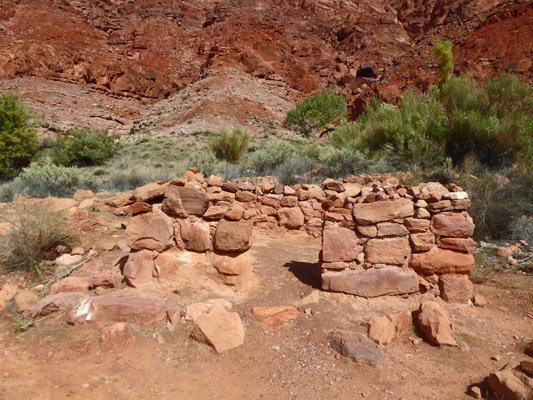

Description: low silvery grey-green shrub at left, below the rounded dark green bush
[4,163,101,201]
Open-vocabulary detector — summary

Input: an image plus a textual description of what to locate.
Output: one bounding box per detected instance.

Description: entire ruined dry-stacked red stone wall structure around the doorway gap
[98,169,475,302]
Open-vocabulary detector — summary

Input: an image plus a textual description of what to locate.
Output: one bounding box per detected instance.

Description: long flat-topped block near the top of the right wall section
[353,198,415,225]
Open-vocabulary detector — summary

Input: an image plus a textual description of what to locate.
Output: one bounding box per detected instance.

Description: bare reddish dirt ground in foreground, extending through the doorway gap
[0,235,533,400]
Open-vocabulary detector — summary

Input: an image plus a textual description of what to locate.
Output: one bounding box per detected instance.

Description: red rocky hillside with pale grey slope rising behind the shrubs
[0,0,533,134]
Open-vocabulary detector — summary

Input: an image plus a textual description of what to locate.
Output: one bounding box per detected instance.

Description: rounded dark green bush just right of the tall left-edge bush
[43,129,115,166]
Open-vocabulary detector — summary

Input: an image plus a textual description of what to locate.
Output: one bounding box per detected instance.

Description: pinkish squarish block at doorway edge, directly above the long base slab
[322,222,363,262]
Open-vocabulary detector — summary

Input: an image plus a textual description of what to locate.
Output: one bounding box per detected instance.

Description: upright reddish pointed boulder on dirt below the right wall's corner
[416,301,457,346]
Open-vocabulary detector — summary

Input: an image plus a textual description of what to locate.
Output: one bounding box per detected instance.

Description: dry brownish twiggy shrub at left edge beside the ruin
[0,204,77,277]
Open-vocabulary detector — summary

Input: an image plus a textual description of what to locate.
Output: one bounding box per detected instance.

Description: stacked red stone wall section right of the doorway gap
[320,183,475,303]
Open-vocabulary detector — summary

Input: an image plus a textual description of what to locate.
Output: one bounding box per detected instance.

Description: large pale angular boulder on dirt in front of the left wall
[191,305,244,353]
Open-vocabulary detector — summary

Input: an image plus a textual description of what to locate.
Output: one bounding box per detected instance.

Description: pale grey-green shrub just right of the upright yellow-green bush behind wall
[250,140,297,176]
